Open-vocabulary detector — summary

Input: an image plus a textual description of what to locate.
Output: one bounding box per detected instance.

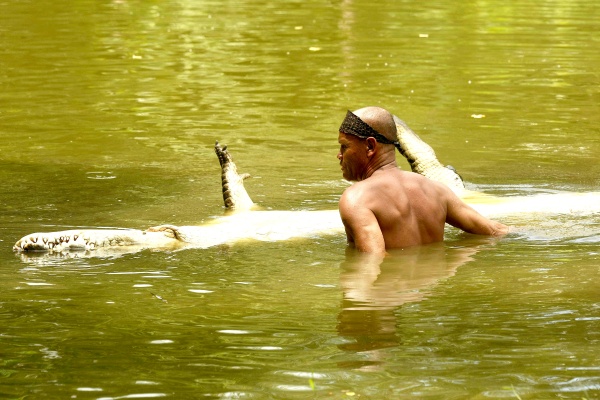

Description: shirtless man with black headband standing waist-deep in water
[337,107,508,253]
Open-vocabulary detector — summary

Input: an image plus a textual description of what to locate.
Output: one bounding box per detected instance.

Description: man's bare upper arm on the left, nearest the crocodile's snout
[340,192,385,253]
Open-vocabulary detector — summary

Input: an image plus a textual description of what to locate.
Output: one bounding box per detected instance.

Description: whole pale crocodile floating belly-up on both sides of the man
[13,116,600,255]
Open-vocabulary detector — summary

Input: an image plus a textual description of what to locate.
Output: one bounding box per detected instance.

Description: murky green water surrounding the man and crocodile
[0,0,600,399]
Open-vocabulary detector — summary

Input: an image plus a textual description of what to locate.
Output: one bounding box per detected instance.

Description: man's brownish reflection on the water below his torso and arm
[337,239,492,369]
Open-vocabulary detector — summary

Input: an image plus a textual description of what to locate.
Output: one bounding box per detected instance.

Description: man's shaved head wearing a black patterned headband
[337,107,397,181]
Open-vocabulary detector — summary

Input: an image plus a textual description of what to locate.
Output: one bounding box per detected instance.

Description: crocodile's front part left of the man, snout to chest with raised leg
[13,141,343,254]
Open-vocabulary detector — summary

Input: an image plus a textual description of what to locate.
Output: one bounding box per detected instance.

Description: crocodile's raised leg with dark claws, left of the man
[215,141,254,211]
